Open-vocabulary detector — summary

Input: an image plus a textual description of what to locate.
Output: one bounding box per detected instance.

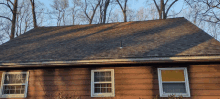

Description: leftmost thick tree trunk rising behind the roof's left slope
[10,0,18,40]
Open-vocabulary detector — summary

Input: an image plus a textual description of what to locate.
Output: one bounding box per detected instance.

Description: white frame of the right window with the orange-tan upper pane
[157,67,190,97]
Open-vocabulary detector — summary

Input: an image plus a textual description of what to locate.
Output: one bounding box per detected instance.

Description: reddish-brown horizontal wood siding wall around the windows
[0,64,220,99]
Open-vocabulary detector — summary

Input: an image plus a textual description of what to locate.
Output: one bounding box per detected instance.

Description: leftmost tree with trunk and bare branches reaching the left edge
[0,0,18,40]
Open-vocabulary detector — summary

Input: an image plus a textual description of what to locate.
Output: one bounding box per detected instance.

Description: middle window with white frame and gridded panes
[91,69,115,97]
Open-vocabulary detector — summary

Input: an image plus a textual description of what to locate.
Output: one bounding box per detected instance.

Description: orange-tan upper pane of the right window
[161,70,185,81]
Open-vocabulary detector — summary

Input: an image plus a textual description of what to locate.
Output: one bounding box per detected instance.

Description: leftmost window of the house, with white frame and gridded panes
[1,72,29,98]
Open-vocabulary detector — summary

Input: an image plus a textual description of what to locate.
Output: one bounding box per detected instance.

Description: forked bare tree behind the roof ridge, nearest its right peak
[153,0,178,19]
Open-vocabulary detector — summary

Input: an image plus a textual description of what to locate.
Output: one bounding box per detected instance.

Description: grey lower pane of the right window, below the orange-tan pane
[162,83,186,93]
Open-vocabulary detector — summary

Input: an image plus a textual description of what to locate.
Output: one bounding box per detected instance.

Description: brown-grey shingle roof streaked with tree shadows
[0,18,220,63]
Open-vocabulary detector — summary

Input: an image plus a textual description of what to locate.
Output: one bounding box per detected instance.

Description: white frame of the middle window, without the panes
[91,69,115,97]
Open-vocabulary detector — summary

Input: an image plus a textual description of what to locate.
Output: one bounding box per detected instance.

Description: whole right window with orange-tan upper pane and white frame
[157,68,190,97]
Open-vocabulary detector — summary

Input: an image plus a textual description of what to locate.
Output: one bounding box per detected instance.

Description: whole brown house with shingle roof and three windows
[0,18,220,99]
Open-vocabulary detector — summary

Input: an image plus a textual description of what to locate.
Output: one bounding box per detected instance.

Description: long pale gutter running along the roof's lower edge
[0,56,220,68]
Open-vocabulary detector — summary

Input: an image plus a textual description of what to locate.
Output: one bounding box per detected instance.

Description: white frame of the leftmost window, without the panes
[0,71,29,98]
